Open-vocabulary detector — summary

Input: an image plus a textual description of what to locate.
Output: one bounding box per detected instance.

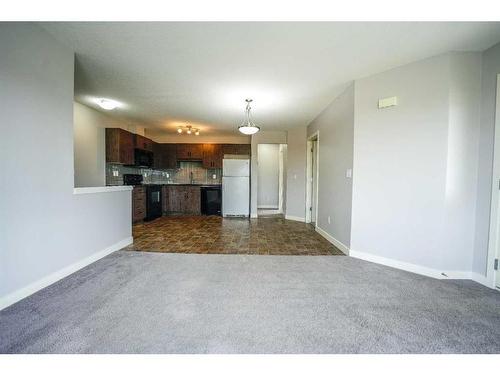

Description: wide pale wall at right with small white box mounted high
[351,54,480,272]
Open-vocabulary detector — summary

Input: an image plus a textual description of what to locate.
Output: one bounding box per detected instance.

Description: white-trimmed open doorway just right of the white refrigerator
[257,143,286,216]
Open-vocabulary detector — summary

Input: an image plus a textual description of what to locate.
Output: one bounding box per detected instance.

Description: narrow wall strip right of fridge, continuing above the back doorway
[250,130,287,217]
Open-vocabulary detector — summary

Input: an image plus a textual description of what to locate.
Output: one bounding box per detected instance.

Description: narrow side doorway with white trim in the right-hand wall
[306,132,319,226]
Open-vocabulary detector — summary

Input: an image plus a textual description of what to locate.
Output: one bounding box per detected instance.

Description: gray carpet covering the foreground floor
[0,251,500,353]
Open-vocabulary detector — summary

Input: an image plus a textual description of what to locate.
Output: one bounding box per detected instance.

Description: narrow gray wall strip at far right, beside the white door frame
[472,43,500,275]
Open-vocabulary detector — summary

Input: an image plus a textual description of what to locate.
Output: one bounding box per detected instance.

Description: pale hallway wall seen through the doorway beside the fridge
[257,144,280,209]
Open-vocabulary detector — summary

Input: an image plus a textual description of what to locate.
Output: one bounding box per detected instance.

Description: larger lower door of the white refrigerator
[222,177,250,217]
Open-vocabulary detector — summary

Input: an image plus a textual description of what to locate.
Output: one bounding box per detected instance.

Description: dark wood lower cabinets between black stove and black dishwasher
[163,185,201,215]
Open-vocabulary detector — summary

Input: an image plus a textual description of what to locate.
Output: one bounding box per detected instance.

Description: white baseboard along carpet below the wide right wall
[349,250,492,288]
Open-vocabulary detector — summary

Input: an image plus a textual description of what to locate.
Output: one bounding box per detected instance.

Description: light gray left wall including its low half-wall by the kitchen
[0,23,131,308]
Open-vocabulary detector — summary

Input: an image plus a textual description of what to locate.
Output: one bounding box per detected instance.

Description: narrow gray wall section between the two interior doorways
[285,126,307,220]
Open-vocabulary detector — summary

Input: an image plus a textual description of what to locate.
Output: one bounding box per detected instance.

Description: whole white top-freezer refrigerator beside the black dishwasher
[222,159,250,217]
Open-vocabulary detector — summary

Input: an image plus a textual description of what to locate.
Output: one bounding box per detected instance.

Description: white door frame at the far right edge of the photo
[486,74,500,290]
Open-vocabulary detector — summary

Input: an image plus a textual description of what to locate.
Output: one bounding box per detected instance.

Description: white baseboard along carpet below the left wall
[0,237,134,310]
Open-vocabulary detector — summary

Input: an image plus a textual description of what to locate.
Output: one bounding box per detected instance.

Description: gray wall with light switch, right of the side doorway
[307,85,354,247]
